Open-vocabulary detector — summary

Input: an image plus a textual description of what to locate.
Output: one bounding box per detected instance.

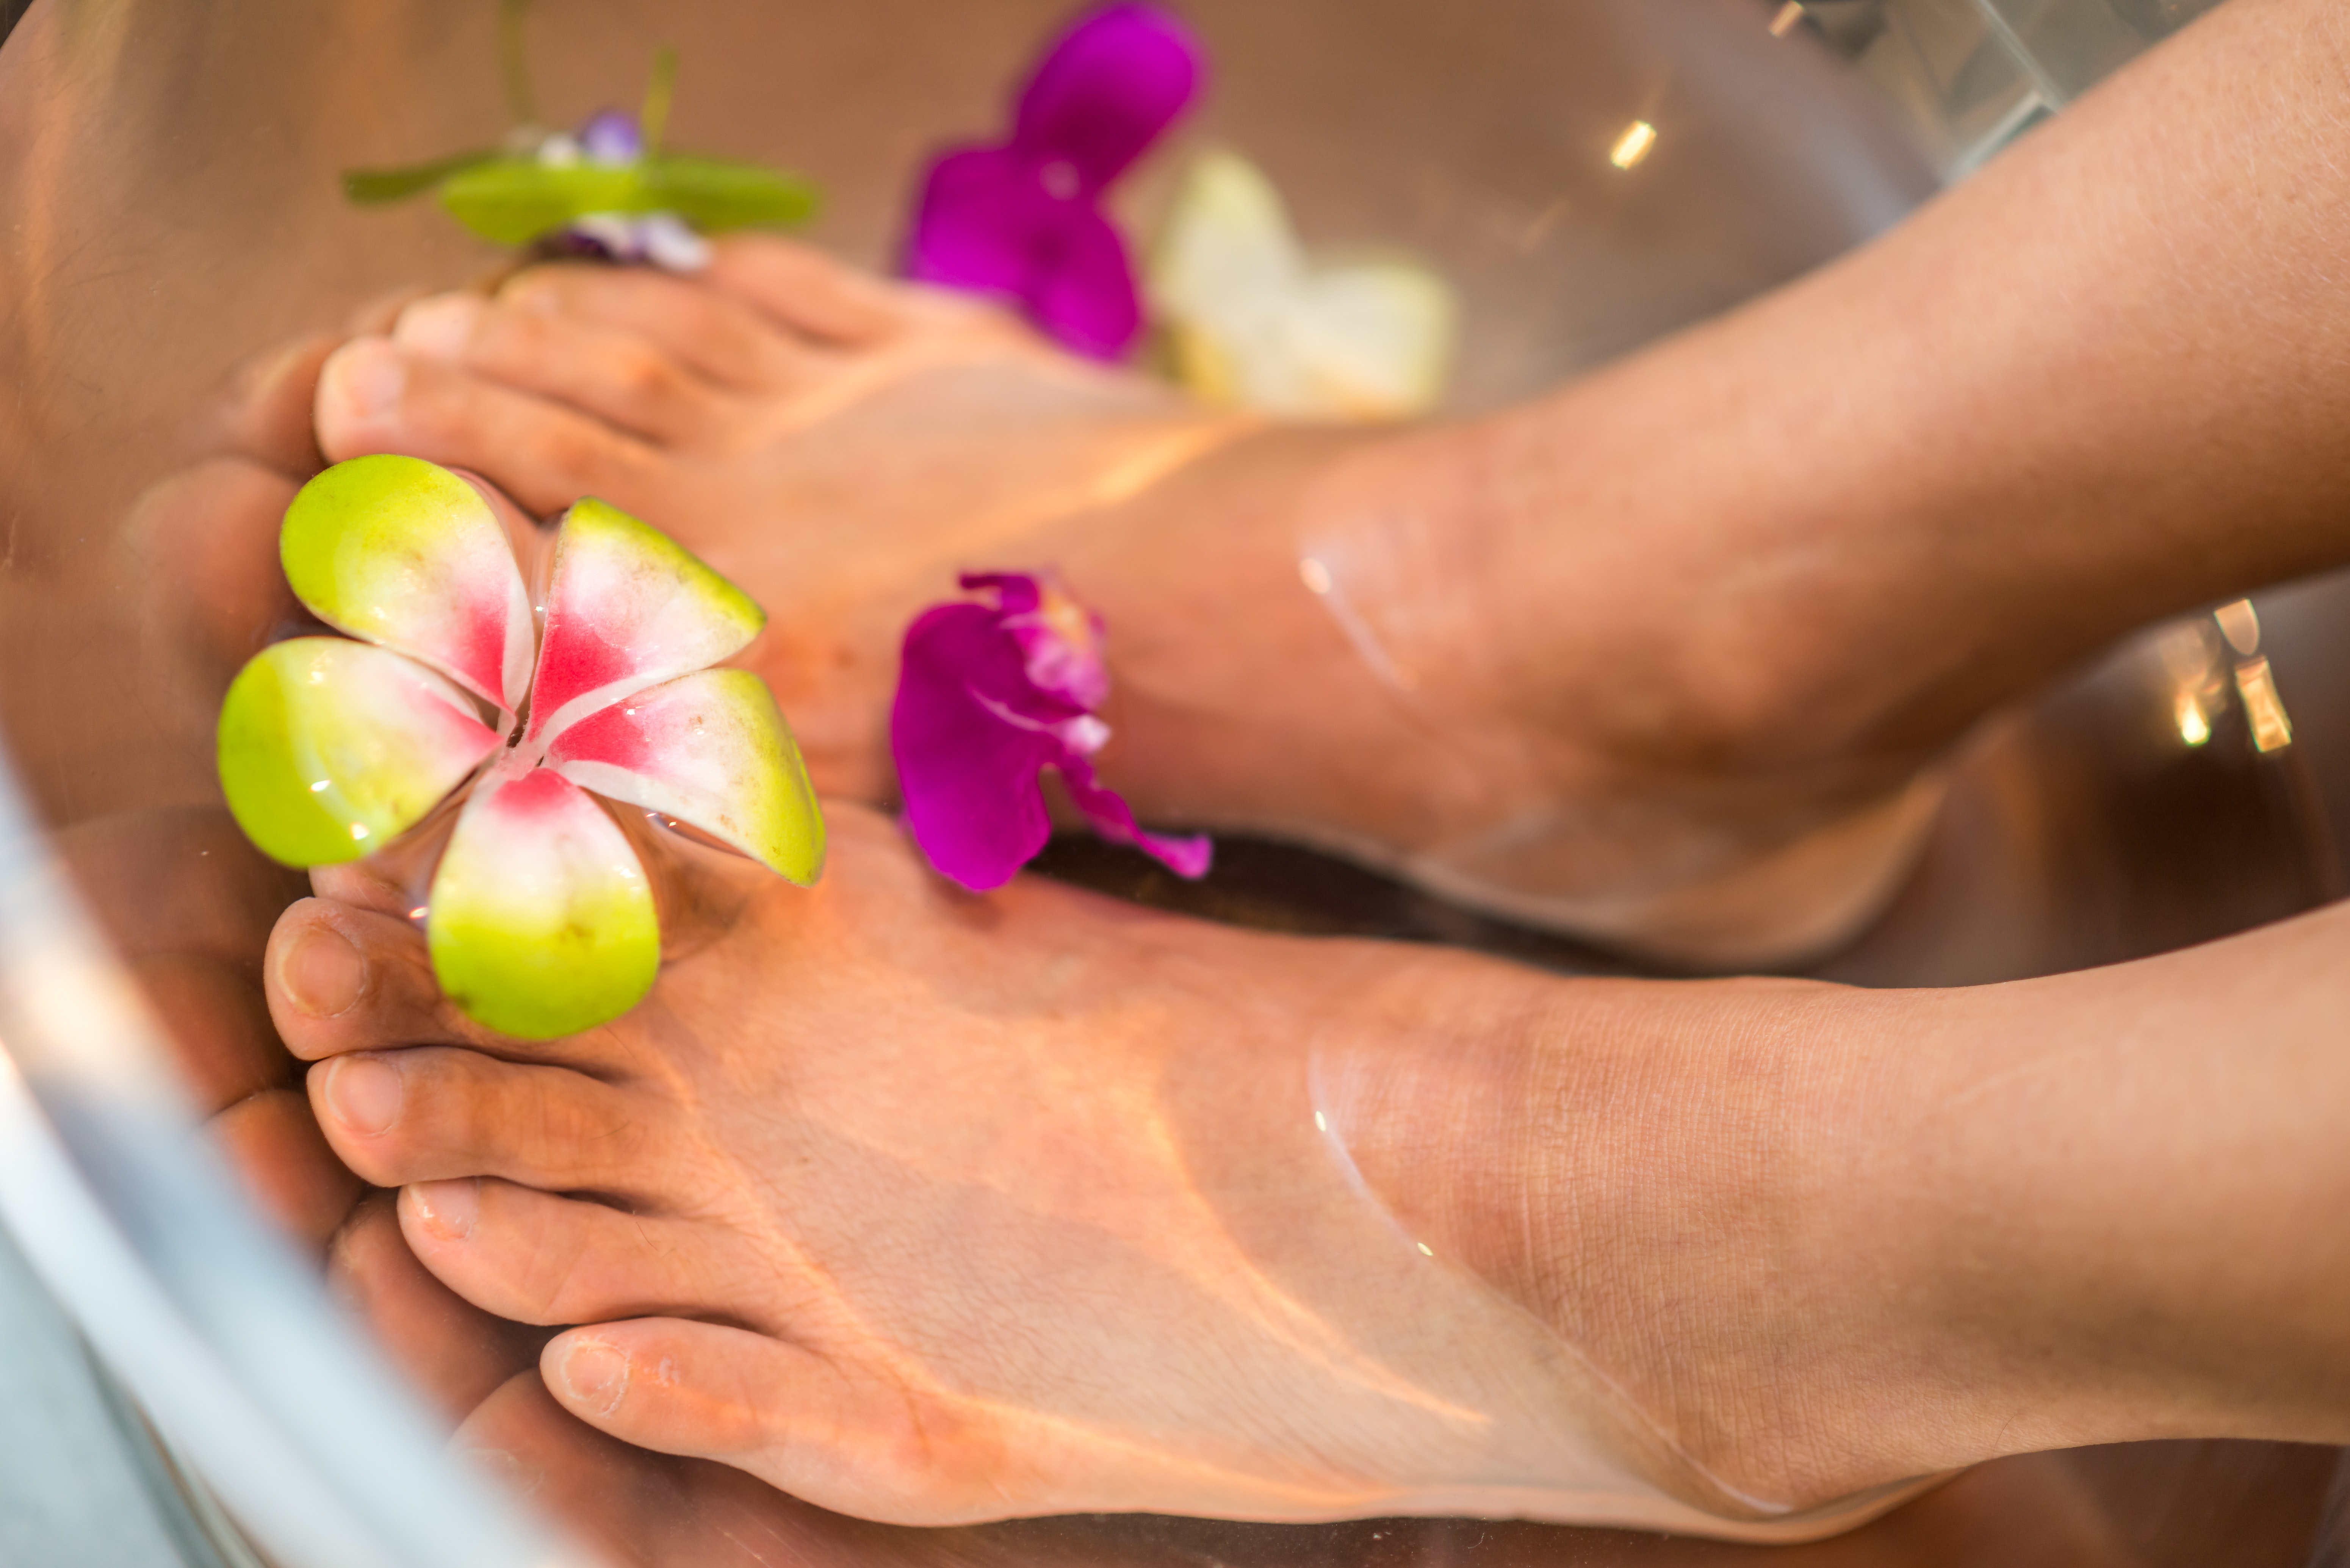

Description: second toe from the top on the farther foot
[498,266,830,393]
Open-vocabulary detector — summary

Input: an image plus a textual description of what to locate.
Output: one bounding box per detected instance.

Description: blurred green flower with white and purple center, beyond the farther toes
[343,49,818,273]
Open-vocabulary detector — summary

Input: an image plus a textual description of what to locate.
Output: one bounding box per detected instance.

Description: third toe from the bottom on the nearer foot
[310,1046,663,1199]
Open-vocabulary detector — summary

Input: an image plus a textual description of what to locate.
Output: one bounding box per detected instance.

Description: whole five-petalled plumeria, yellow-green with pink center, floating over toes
[219,456,825,1039]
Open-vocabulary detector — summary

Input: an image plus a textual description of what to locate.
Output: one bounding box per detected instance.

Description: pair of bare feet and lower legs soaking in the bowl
[27,0,2350,1540]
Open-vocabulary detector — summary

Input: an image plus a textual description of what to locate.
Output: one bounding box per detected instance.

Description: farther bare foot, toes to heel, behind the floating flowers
[317,240,1932,966]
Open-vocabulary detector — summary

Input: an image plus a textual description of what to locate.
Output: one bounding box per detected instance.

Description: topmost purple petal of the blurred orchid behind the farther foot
[1013,5,1203,191]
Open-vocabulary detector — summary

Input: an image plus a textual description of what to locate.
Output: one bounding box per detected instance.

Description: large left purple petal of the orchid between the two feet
[888,604,1067,893]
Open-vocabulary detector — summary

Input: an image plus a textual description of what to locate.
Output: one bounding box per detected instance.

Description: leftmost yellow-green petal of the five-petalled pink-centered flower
[219,637,498,865]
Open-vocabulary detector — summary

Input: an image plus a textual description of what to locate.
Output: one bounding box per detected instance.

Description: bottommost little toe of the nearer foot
[538,1319,1018,1523]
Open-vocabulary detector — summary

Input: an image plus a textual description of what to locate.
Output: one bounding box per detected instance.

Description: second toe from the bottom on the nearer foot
[399,1175,745,1324]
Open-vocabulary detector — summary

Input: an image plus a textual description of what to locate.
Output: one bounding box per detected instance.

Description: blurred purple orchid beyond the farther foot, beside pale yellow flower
[907,2,1206,360]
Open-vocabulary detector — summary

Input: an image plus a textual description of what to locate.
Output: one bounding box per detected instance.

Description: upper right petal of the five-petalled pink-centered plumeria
[526,498,766,743]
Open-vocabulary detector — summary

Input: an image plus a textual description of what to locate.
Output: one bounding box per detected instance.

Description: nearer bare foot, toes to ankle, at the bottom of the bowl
[268,806,2096,1537]
